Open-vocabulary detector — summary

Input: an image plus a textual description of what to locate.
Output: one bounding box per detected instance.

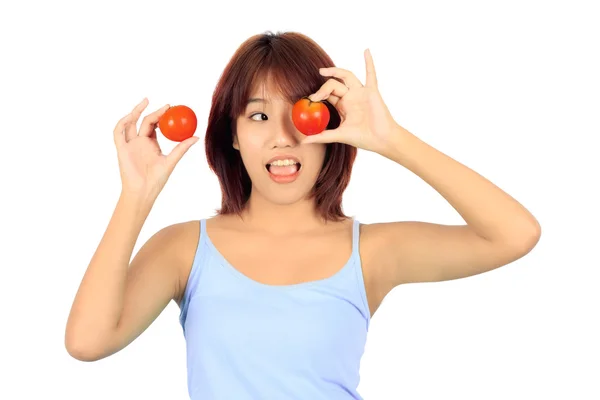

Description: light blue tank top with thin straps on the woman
[180,219,370,400]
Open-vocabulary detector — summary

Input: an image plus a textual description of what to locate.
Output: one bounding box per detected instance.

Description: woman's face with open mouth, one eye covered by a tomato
[233,81,326,205]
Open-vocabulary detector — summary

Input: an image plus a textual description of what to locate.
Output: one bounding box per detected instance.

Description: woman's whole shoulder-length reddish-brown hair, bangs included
[205,32,356,220]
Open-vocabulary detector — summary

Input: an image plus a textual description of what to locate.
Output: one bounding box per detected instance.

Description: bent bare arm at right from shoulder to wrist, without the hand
[366,129,541,304]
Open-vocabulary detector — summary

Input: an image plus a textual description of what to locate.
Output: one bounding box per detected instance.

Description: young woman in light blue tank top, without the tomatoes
[66,33,540,400]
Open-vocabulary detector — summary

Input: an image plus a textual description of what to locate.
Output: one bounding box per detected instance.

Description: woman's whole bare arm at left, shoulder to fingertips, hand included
[65,98,198,361]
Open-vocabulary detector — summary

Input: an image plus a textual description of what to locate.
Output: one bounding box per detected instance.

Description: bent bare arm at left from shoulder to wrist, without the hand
[65,195,193,361]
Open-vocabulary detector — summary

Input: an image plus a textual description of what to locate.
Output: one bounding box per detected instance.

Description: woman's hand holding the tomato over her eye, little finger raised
[302,50,404,157]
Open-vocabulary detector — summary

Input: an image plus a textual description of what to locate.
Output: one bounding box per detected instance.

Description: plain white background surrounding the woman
[0,0,600,400]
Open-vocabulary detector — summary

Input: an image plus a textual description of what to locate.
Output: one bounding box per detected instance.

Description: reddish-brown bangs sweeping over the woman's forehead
[230,33,333,119]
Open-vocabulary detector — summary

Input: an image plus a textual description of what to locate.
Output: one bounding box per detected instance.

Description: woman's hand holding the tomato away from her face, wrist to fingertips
[114,98,199,198]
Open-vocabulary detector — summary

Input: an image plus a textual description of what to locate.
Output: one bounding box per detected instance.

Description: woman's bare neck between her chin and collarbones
[242,191,324,234]
